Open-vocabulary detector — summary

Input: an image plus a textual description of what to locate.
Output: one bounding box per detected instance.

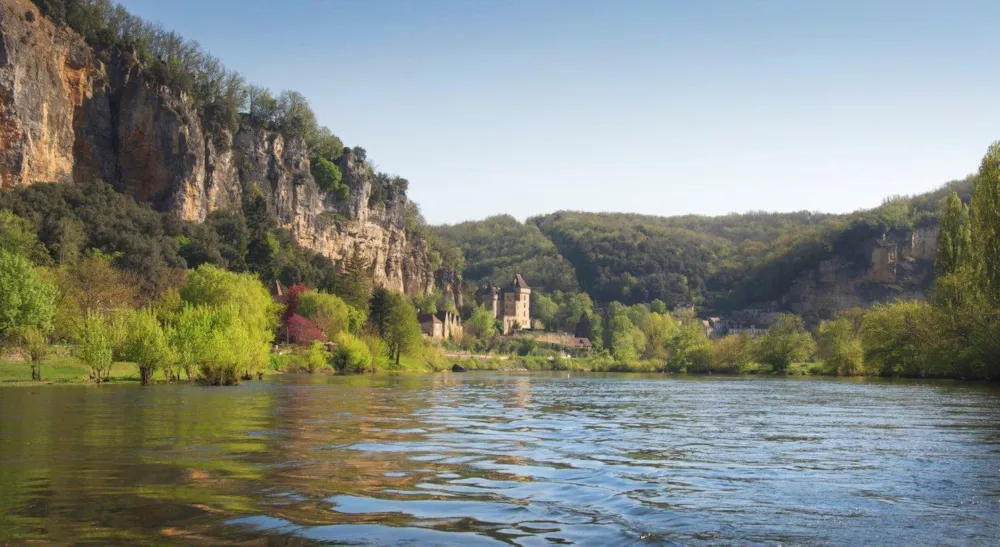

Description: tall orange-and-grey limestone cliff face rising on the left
[0,0,434,294]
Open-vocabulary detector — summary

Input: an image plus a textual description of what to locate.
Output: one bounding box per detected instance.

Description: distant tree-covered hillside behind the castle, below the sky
[434,177,973,310]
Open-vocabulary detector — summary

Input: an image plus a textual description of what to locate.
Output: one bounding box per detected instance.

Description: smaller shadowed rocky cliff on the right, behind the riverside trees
[780,225,940,320]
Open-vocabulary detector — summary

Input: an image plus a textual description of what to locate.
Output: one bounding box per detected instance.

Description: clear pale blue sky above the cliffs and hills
[123,0,1000,223]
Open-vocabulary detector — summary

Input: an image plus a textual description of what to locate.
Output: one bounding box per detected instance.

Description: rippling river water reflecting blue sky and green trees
[0,373,1000,545]
